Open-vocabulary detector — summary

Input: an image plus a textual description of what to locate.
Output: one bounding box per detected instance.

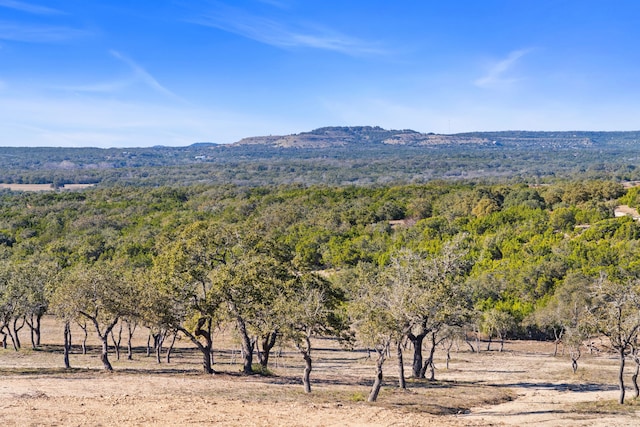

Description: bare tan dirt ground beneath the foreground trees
[0,319,640,426]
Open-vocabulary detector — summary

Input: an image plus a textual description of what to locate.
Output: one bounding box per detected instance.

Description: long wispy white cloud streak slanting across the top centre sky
[190,4,385,55]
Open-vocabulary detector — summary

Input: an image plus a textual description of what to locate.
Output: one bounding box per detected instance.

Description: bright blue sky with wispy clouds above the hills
[0,0,640,147]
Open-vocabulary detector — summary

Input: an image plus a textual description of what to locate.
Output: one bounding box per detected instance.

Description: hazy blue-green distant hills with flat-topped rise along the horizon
[0,126,640,191]
